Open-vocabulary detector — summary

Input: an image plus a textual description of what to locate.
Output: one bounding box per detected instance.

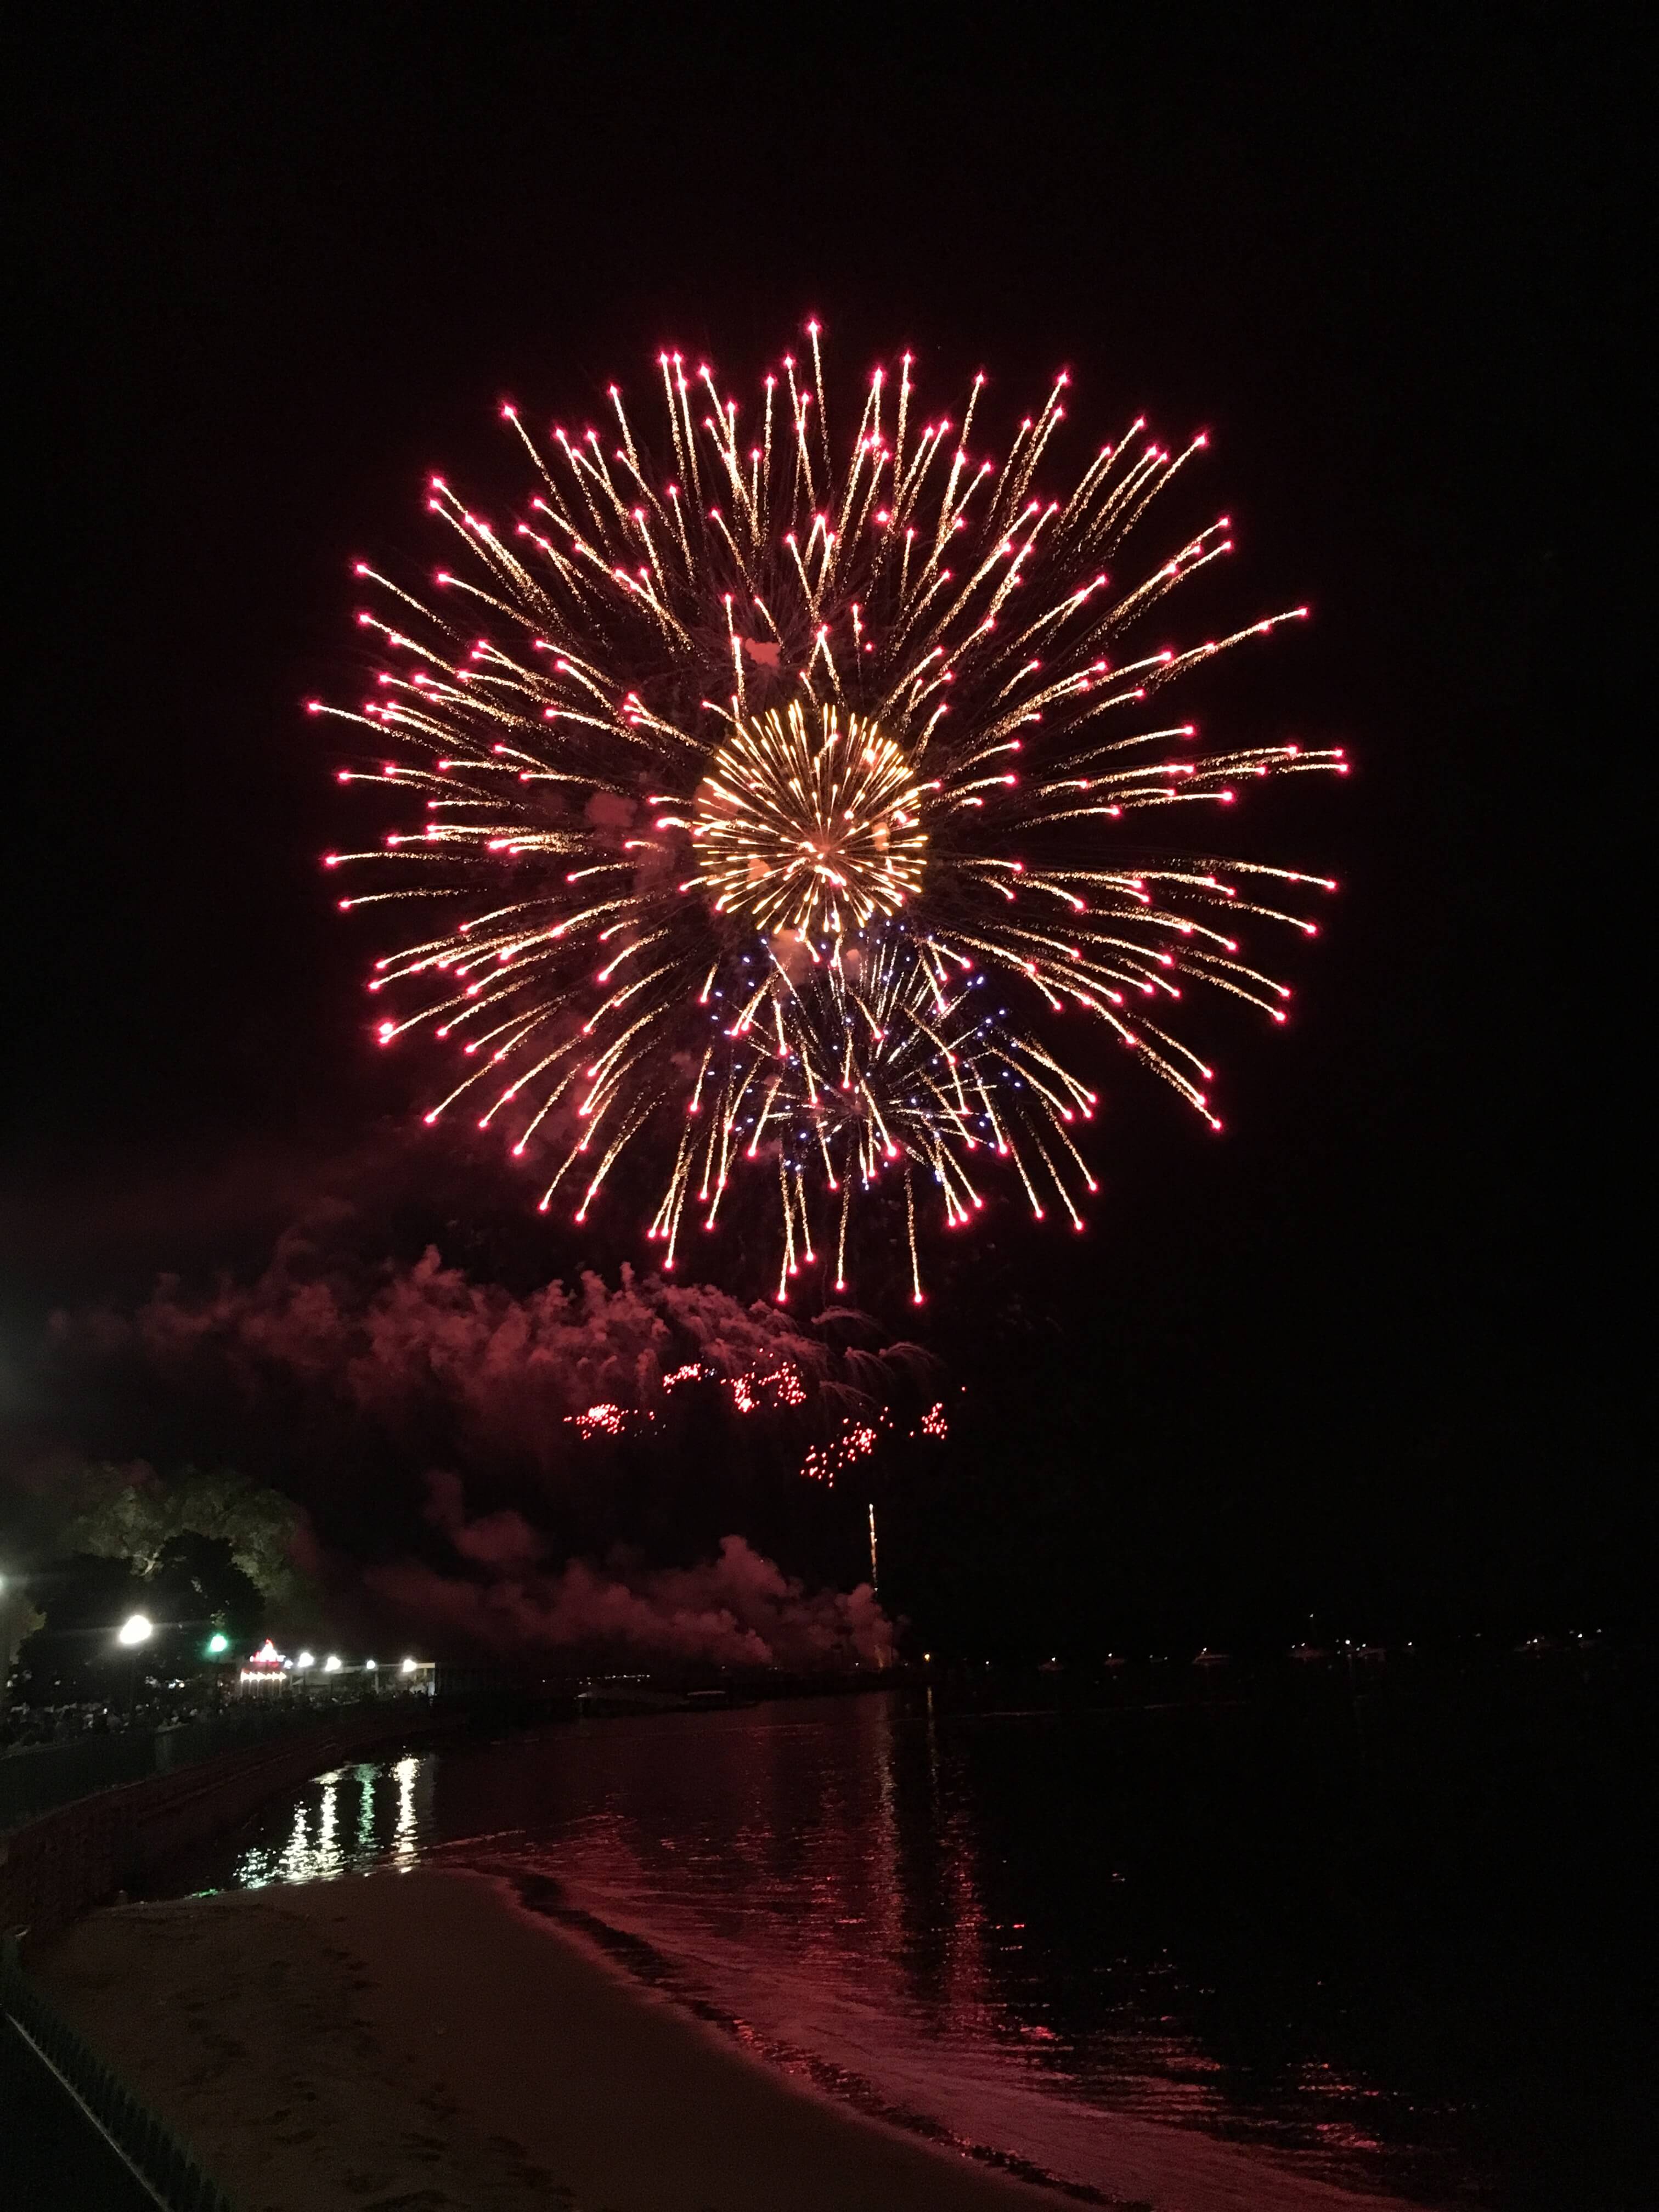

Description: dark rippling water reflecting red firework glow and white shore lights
[166,1695,1644,2212]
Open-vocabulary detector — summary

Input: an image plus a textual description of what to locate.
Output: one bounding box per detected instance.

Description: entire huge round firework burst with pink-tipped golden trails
[312,325,1345,1301]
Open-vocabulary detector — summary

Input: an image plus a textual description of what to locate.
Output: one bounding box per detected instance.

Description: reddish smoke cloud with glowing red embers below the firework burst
[36,1219,934,1670]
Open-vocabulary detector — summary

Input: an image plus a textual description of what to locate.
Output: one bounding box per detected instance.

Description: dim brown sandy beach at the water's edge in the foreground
[31,1871,1092,2212]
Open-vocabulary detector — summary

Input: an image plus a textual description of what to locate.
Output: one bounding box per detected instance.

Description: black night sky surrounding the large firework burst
[0,7,1648,1637]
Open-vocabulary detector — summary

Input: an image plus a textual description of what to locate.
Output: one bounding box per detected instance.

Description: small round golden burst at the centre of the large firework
[690,706,927,938]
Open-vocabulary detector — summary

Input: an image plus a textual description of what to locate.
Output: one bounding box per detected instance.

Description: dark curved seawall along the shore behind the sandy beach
[0,1708,467,1936]
